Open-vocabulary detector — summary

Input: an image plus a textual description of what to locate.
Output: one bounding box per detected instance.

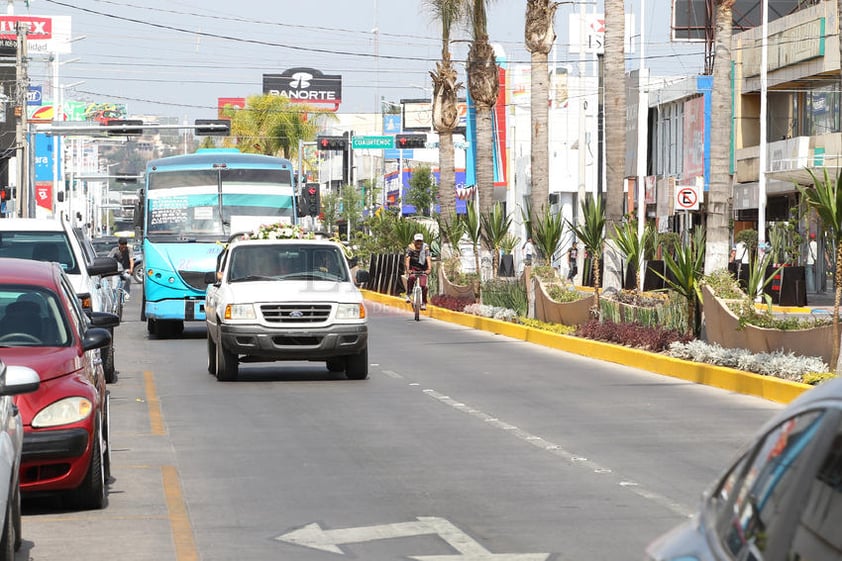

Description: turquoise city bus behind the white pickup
[135,149,298,337]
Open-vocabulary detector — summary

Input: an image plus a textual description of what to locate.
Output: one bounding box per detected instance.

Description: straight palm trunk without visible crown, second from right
[602,0,626,286]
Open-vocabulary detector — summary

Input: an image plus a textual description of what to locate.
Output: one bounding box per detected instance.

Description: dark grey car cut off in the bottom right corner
[646,378,842,561]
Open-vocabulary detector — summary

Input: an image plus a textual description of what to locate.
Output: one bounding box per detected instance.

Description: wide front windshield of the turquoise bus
[146,164,294,240]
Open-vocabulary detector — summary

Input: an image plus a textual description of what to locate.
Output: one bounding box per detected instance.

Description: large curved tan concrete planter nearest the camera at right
[702,286,833,364]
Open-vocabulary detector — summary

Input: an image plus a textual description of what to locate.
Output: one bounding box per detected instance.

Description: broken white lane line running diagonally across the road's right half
[420,384,692,517]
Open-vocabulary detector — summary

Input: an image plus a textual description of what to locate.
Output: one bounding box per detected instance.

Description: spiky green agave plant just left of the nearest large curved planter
[655,228,705,336]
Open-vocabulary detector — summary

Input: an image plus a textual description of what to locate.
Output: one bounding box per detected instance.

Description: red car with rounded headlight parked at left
[0,258,119,509]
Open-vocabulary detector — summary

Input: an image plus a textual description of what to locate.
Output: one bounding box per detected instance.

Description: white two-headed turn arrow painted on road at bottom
[275,516,550,561]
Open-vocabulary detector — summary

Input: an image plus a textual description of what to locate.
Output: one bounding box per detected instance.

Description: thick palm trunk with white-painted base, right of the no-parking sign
[705,0,733,273]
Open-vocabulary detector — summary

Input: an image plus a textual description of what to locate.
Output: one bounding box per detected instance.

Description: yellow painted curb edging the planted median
[362,290,813,403]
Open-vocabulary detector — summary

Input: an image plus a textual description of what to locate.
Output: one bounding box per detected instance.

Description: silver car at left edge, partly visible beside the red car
[0,361,41,561]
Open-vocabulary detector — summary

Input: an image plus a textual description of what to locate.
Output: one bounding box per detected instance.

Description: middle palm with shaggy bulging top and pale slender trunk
[524,0,558,212]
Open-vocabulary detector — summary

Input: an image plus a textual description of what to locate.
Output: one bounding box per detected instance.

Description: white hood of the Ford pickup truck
[223,280,363,303]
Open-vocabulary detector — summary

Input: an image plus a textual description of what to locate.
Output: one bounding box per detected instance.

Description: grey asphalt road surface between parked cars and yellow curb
[16,296,781,561]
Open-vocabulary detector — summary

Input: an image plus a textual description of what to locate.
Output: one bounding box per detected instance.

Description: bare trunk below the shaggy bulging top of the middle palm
[529,52,550,215]
